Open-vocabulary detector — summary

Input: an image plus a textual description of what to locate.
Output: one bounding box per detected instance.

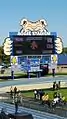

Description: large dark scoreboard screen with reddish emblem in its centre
[12,35,55,55]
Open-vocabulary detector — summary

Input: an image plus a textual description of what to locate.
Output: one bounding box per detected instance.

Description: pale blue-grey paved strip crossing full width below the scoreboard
[0,76,67,87]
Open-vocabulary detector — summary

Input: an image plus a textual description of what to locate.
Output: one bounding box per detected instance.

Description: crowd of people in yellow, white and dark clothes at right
[34,89,66,107]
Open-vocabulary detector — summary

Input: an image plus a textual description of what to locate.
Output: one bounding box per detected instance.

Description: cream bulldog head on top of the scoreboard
[20,19,49,35]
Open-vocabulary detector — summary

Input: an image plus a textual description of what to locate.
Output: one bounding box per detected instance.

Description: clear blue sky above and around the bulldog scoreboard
[0,0,67,47]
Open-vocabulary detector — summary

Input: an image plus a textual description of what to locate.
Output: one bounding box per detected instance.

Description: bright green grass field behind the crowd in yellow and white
[22,88,67,101]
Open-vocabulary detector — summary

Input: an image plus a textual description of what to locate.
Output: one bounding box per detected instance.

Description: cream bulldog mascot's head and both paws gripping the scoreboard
[4,19,63,55]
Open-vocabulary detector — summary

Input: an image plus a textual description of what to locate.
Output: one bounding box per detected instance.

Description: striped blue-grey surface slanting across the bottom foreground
[0,102,66,119]
